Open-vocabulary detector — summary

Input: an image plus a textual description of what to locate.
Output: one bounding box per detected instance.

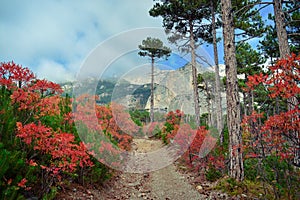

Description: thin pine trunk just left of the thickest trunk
[210,0,224,144]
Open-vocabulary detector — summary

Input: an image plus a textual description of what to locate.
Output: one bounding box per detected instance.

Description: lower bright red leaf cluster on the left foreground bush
[17,122,93,174]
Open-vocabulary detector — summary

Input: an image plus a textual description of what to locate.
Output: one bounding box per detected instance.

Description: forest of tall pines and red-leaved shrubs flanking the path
[0,0,300,200]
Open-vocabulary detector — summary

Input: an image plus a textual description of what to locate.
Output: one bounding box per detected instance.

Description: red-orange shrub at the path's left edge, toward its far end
[74,95,134,150]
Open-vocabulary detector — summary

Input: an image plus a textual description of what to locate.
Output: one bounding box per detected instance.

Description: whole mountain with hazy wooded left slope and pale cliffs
[62,64,225,114]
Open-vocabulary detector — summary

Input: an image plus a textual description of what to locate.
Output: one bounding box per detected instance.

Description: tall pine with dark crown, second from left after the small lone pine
[149,0,212,126]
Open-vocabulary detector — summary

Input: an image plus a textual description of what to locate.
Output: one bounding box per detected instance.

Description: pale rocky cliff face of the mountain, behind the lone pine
[123,63,220,115]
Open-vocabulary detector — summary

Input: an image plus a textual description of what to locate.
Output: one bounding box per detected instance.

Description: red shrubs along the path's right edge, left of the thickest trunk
[162,110,225,170]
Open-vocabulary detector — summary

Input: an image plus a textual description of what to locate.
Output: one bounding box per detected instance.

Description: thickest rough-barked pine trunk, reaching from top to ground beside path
[221,0,244,181]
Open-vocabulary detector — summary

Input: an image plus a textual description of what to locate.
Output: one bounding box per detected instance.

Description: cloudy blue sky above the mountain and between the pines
[0,0,276,83]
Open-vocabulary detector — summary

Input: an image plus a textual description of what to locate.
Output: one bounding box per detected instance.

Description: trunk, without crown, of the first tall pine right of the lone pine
[189,23,200,127]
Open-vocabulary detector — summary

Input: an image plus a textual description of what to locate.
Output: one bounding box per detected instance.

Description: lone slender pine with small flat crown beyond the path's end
[138,37,171,122]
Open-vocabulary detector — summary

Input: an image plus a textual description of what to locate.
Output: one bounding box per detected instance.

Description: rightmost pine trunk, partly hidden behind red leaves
[274,0,300,166]
